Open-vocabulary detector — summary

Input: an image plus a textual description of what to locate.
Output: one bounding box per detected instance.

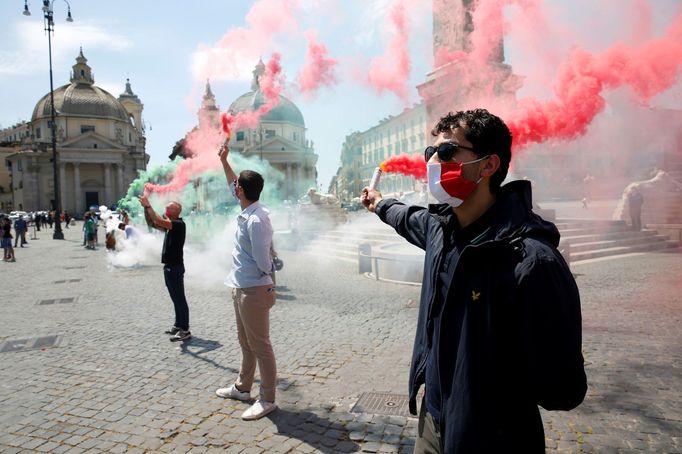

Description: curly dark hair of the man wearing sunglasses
[431,109,512,192]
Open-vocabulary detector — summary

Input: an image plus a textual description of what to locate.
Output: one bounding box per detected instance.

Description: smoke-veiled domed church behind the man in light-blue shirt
[228,60,318,200]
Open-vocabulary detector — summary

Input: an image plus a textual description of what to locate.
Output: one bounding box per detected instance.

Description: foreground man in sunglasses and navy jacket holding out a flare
[362,109,587,454]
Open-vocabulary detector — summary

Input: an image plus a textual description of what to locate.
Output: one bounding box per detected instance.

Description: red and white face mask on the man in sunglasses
[426,156,488,207]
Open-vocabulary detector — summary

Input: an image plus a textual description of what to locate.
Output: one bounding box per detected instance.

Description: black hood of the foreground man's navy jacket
[429,180,561,247]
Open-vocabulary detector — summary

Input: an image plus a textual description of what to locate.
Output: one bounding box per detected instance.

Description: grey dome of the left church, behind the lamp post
[31,50,130,122]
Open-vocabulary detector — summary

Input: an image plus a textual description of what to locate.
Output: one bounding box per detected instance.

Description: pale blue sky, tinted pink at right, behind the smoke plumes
[0,0,682,189]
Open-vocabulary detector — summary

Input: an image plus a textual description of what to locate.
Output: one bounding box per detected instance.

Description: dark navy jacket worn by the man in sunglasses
[376,181,587,454]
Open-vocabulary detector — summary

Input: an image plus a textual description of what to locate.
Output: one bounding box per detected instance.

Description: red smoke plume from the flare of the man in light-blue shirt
[144,54,282,195]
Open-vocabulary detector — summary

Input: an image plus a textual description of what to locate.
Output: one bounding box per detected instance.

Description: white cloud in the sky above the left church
[0,21,133,75]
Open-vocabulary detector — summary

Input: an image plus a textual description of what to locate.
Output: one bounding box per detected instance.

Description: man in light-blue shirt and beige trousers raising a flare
[216,145,277,420]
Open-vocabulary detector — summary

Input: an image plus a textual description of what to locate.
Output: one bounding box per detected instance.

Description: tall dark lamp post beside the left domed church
[23,0,73,240]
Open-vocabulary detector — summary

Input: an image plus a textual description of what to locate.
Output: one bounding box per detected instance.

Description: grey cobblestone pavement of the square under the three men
[0,225,682,453]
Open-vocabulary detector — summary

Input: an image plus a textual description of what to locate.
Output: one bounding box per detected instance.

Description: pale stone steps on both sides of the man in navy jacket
[301,214,679,270]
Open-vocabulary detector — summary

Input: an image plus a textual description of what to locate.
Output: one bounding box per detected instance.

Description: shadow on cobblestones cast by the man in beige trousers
[266,408,360,454]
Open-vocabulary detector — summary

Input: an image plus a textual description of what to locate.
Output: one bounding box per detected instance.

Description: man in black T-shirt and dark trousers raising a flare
[139,196,192,342]
